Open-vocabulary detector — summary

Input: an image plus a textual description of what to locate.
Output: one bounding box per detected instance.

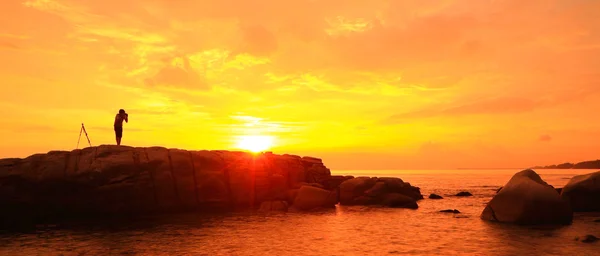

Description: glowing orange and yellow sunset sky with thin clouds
[0,0,600,170]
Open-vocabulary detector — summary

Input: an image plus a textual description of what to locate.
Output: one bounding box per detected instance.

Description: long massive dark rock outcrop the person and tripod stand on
[0,145,420,225]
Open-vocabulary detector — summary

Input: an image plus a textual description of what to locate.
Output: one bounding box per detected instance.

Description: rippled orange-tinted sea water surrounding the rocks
[0,170,600,256]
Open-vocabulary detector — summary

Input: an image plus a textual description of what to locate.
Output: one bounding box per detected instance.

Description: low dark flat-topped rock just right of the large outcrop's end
[339,177,423,208]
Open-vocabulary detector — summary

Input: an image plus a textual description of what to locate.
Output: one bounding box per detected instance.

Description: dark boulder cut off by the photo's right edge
[561,171,600,212]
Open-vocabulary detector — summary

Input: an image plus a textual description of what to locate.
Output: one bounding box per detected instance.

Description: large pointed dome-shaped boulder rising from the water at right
[480,170,573,225]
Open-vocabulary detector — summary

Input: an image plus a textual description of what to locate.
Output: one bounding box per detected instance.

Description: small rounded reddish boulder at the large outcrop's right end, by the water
[292,186,337,211]
